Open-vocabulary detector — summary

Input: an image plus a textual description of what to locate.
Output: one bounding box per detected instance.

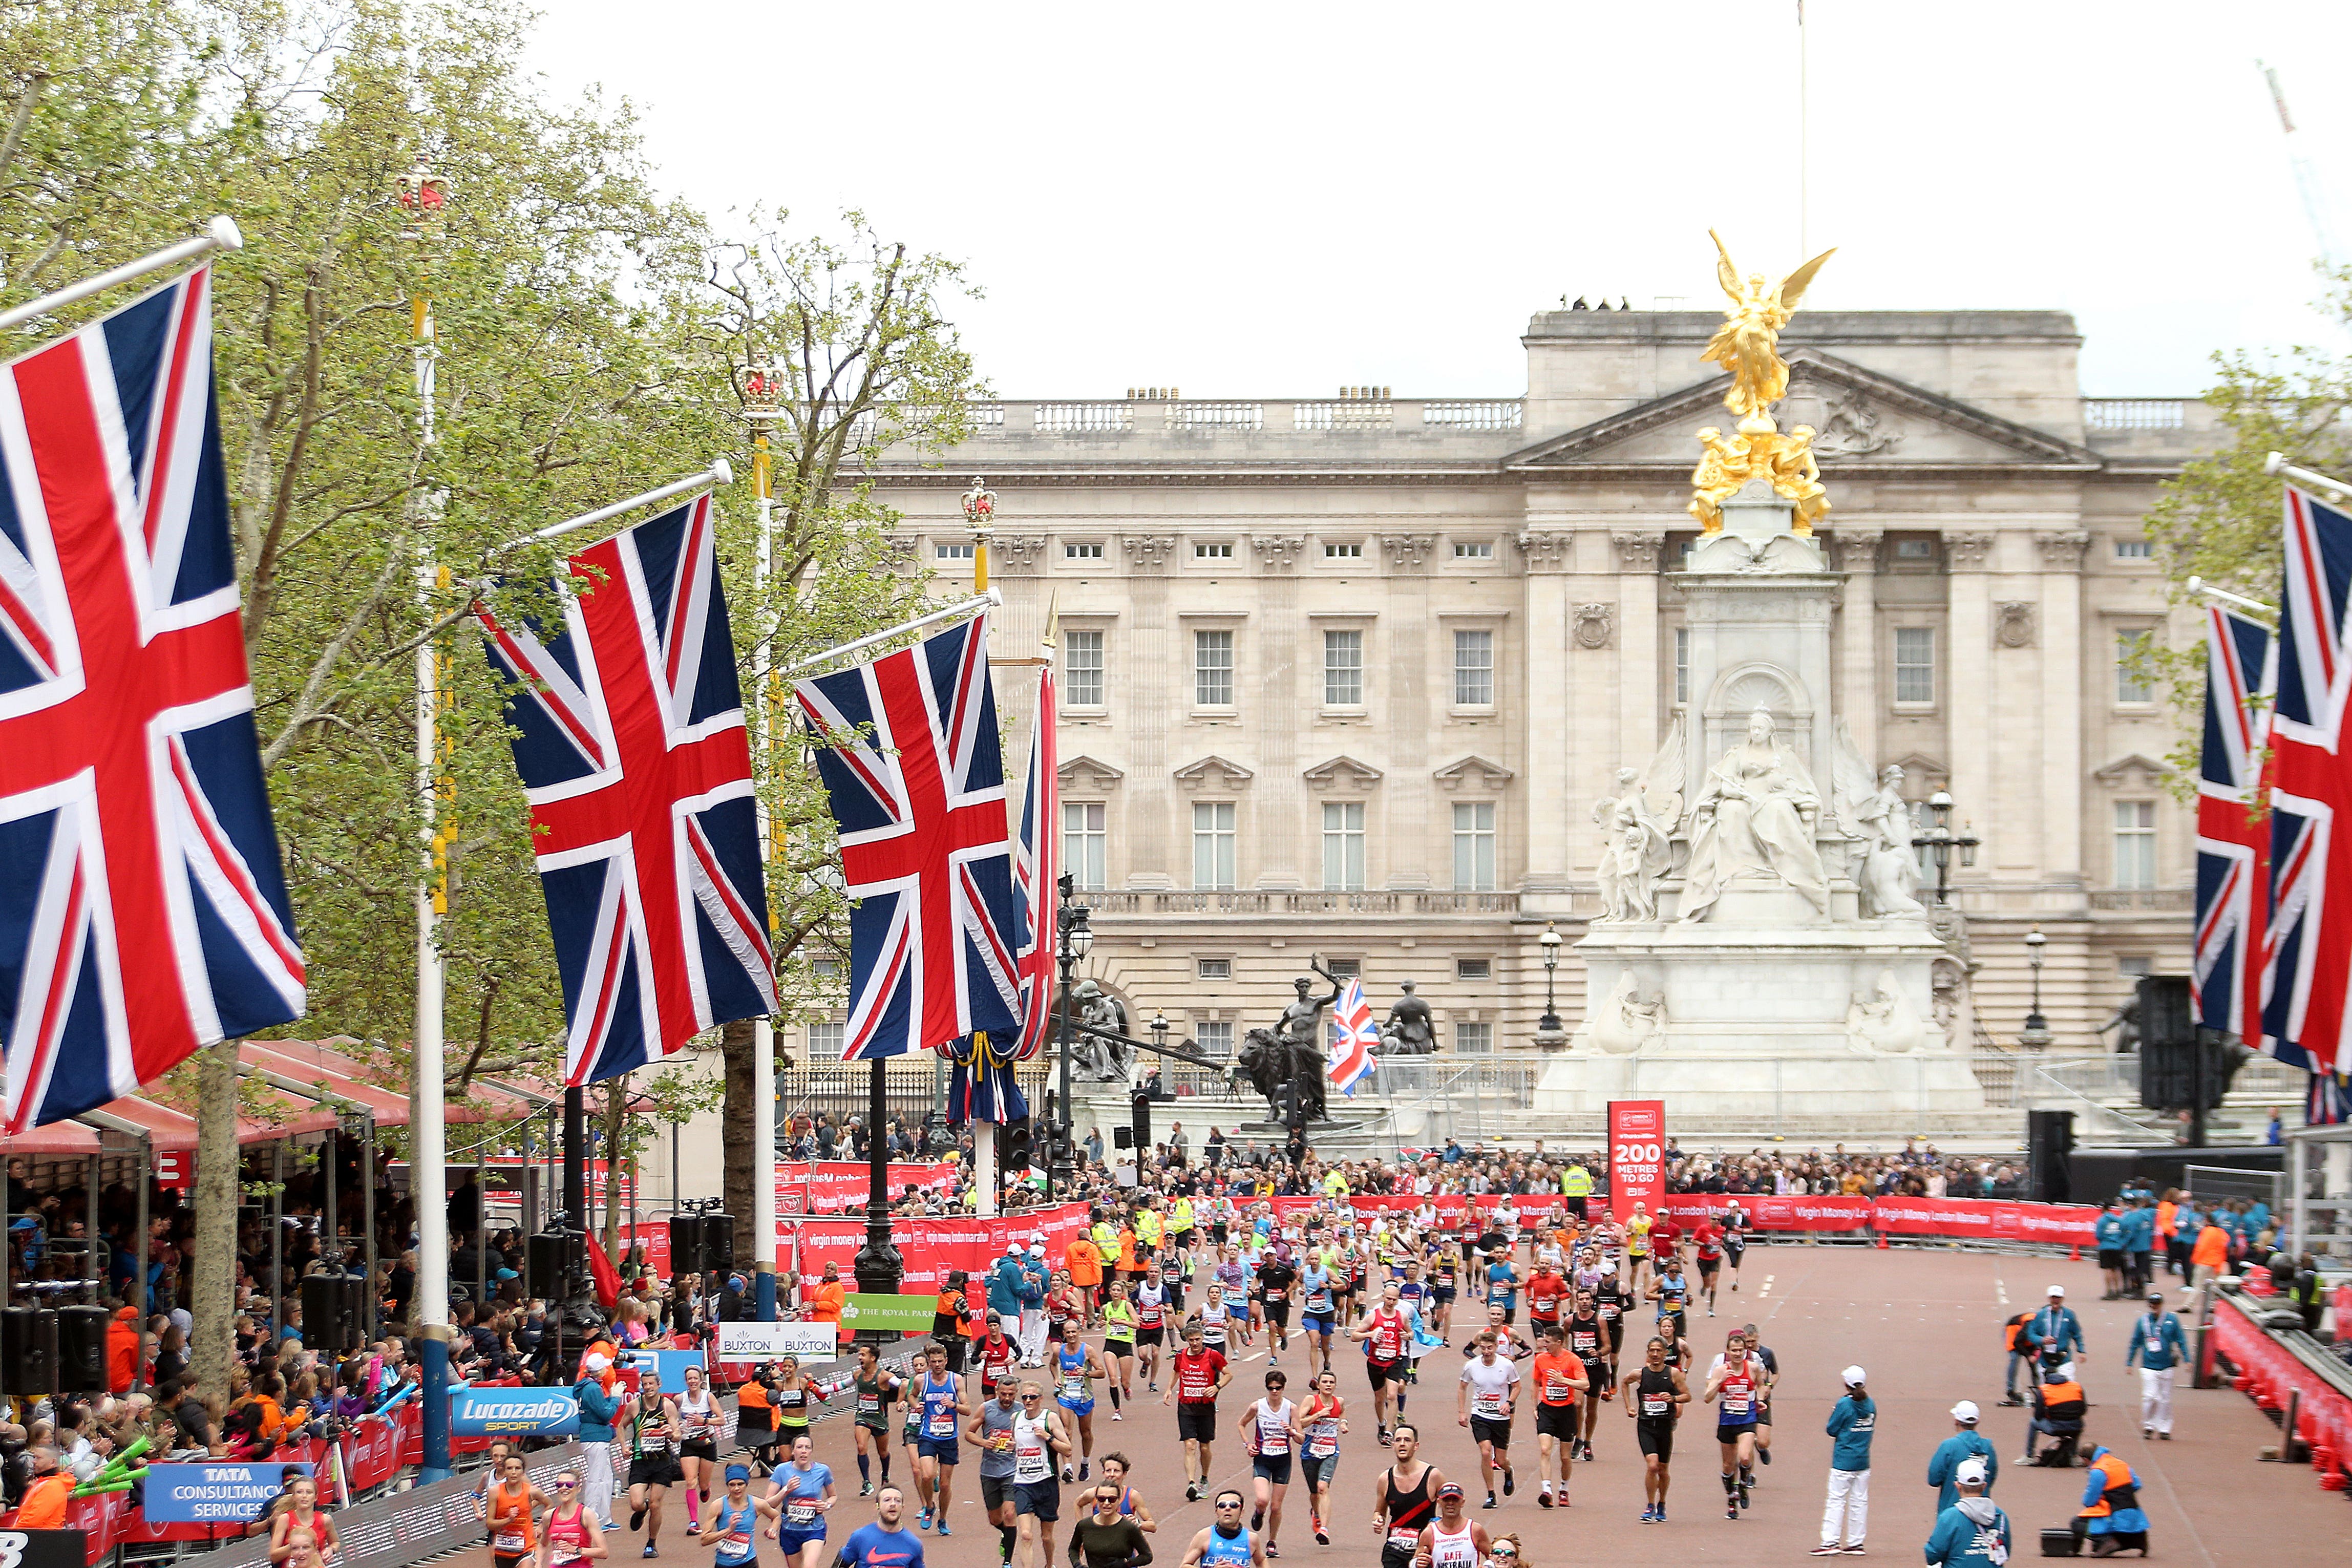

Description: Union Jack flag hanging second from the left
[475,496,776,1084]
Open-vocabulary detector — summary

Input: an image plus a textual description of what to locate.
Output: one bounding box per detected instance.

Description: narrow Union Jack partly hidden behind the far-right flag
[2192,604,2279,1046]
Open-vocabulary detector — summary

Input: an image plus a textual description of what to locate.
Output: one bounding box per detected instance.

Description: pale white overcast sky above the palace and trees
[532,0,2352,397]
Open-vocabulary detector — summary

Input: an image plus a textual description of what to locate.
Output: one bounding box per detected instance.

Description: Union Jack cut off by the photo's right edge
[2249,486,2352,1091]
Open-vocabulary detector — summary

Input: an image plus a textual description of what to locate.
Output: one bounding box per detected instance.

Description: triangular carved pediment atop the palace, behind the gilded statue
[1503,348,2101,473]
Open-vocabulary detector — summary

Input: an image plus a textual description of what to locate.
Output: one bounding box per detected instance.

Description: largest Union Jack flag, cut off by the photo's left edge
[0,268,303,1133]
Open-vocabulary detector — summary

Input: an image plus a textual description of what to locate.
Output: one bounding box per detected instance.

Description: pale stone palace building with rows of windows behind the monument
[856,310,2211,1055]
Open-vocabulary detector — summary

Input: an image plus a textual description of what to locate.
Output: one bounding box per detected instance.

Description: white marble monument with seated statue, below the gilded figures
[1536,482,1985,1121]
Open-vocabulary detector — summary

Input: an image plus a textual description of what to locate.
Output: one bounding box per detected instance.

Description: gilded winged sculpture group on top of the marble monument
[1691,228,1837,536]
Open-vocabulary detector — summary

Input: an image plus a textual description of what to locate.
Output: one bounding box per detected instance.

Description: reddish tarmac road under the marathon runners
[459,1246,2352,1568]
